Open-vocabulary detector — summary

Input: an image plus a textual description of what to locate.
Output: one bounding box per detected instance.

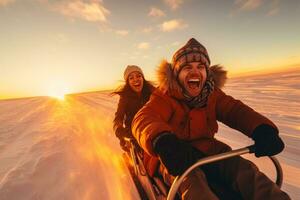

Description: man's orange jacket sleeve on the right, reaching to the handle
[215,88,277,137]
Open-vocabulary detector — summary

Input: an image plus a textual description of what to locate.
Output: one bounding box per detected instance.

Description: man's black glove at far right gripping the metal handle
[252,124,284,157]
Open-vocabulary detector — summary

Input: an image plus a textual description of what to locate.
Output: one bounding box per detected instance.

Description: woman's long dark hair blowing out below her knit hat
[111,77,154,96]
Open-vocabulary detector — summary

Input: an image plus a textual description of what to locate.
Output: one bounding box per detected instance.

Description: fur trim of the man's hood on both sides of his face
[157,60,227,98]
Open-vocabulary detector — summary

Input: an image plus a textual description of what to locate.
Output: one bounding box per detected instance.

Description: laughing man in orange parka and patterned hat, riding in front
[132,38,289,200]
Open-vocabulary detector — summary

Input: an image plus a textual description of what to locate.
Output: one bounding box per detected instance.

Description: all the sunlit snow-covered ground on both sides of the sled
[0,68,300,200]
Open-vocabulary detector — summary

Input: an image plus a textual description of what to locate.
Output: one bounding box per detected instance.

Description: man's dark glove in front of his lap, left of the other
[154,132,204,176]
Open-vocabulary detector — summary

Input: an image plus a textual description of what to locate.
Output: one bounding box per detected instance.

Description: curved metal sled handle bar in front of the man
[167,145,283,200]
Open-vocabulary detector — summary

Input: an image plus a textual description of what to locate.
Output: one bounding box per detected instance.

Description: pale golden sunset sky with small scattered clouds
[0,0,300,99]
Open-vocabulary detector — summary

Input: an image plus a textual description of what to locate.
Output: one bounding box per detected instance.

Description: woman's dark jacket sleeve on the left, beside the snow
[113,96,126,138]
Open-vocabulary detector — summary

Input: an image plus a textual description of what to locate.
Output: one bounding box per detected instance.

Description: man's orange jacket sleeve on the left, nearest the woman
[132,91,172,156]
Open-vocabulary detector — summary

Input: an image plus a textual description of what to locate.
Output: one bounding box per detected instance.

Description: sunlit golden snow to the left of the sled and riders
[0,93,138,200]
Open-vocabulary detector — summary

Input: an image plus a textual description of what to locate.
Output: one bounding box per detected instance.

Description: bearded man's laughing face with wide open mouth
[178,62,207,97]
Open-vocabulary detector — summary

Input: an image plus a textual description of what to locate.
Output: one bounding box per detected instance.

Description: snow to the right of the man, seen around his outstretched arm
[217,70,300,199]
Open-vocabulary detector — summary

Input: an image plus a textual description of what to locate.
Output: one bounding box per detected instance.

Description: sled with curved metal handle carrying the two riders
[124,138,283,200]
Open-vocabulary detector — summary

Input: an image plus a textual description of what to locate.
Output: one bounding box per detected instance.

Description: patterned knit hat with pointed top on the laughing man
[172,38,210,77]
